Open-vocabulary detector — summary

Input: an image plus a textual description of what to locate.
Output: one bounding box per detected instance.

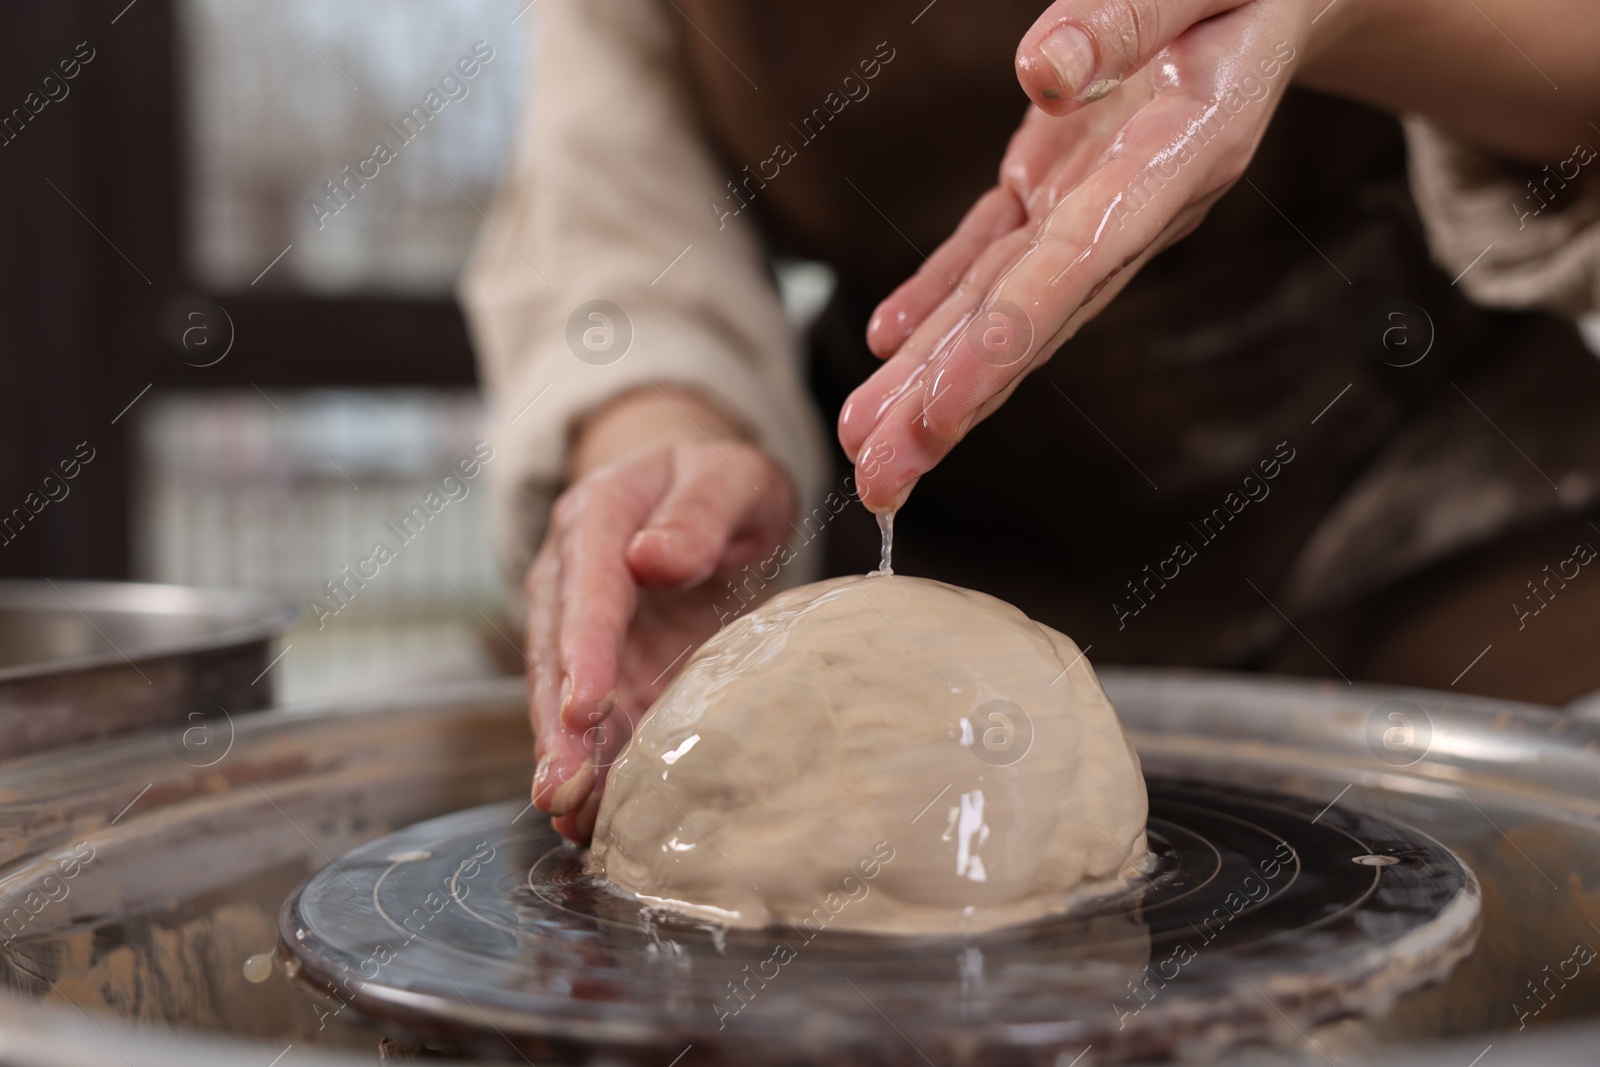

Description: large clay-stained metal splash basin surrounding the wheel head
[0,669,1600,1067]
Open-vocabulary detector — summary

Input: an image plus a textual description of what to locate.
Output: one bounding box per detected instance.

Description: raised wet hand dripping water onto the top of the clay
[838,0,1312,512]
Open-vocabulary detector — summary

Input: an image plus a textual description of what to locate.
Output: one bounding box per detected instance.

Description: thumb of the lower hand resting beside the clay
[627,442,792,587]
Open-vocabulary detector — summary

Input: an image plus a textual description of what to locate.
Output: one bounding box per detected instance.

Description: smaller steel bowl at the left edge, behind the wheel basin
[0,579,294,757]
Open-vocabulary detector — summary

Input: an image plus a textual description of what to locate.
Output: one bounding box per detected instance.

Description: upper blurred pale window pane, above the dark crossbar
[179,0,538,296]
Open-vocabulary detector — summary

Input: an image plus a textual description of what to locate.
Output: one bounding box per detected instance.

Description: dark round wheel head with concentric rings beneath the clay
[278,779,1480,1067]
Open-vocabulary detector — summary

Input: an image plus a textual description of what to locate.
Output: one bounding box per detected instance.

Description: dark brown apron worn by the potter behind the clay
[672,0,1600,699]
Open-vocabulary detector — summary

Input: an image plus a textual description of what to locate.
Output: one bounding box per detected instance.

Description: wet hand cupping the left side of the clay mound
[526,390,795,841]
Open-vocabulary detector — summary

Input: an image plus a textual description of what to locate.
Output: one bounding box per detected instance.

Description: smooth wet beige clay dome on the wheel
[590,574,1147,934]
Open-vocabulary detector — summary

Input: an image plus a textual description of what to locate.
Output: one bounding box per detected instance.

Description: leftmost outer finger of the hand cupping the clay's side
[526,556,592,814]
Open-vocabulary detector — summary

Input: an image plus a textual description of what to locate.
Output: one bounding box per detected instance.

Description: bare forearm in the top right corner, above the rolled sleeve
[1296,0,1600,163]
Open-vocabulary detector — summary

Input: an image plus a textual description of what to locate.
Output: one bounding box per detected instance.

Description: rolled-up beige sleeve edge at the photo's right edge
[1405,115,1600,315]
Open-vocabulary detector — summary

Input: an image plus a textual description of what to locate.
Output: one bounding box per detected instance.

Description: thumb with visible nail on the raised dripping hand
[1016,0,1246,115]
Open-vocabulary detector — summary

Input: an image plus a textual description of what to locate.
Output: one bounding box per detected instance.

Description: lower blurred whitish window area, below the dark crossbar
[134,389,522,701]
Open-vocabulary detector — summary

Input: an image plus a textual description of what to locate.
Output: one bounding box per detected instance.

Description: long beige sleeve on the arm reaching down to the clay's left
[461,0,826,604]
